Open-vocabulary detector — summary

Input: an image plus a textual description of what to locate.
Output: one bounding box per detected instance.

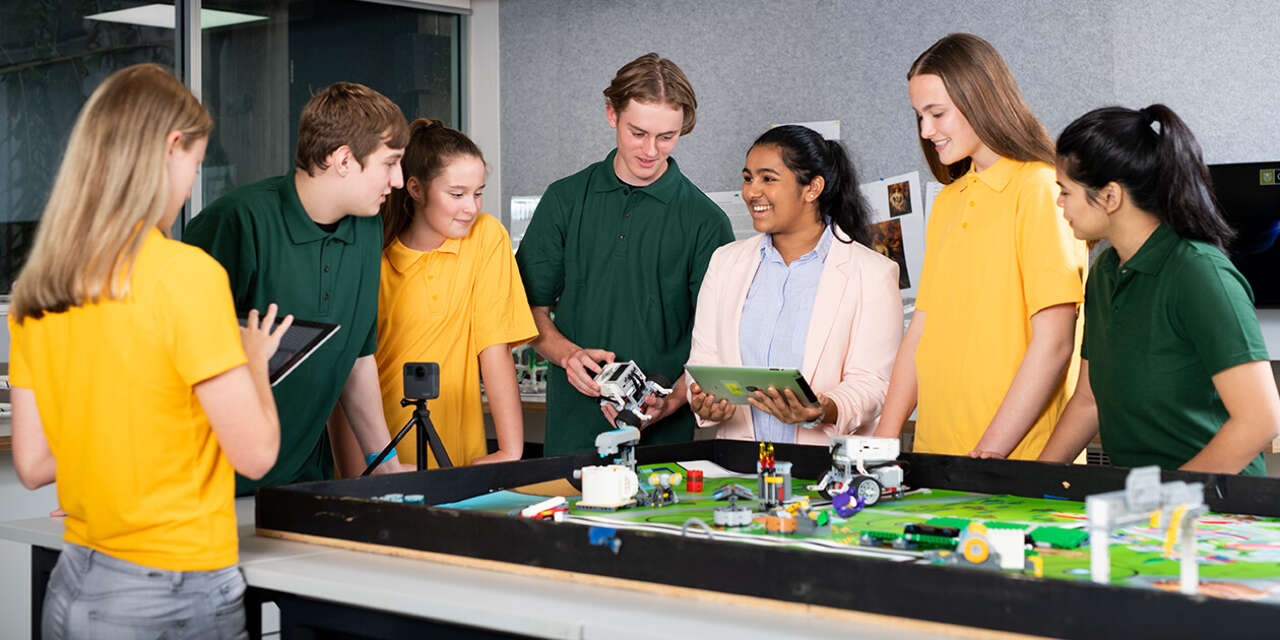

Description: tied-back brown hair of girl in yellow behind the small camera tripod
[381,118,484,247]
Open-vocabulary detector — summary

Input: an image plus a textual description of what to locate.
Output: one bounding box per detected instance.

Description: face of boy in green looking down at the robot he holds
[604,100,685,187]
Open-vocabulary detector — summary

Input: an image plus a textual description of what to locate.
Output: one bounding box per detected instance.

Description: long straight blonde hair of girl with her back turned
[10,64,214,323]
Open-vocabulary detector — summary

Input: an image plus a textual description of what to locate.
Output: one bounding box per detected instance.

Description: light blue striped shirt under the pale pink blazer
[737,225,835,443]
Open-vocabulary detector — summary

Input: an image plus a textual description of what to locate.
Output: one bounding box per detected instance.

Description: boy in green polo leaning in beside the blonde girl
[183,82,408,494]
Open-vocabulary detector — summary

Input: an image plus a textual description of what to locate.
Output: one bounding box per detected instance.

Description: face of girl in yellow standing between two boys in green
[408,155,485,248]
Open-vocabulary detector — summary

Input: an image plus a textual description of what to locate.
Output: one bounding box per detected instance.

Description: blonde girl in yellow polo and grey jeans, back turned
[9,64,292,639]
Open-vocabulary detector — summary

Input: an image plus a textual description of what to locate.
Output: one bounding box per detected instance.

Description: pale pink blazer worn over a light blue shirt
[686,234,902,444]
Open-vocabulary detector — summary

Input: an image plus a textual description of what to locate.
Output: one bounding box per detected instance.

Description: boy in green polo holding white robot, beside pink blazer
[516,54,733,456]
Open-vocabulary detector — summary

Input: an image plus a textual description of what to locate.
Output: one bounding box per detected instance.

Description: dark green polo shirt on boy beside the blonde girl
[182,173,383,494]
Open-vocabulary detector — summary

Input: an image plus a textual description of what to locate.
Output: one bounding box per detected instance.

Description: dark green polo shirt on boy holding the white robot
[516,150,733,456]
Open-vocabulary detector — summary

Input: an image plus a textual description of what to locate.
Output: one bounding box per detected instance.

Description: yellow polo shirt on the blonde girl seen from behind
[9,229,246,571]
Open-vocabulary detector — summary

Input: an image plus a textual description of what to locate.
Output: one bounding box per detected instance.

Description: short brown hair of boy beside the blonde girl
[293,82,408,175]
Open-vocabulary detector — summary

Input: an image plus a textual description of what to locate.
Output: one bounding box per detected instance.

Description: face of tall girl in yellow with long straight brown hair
[908,73,997,172]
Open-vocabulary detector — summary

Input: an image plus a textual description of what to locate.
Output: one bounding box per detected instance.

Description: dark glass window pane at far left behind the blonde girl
[0,0,174,296]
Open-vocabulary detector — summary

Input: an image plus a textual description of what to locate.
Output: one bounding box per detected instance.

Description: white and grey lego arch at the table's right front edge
[1084,466,1208,594]
